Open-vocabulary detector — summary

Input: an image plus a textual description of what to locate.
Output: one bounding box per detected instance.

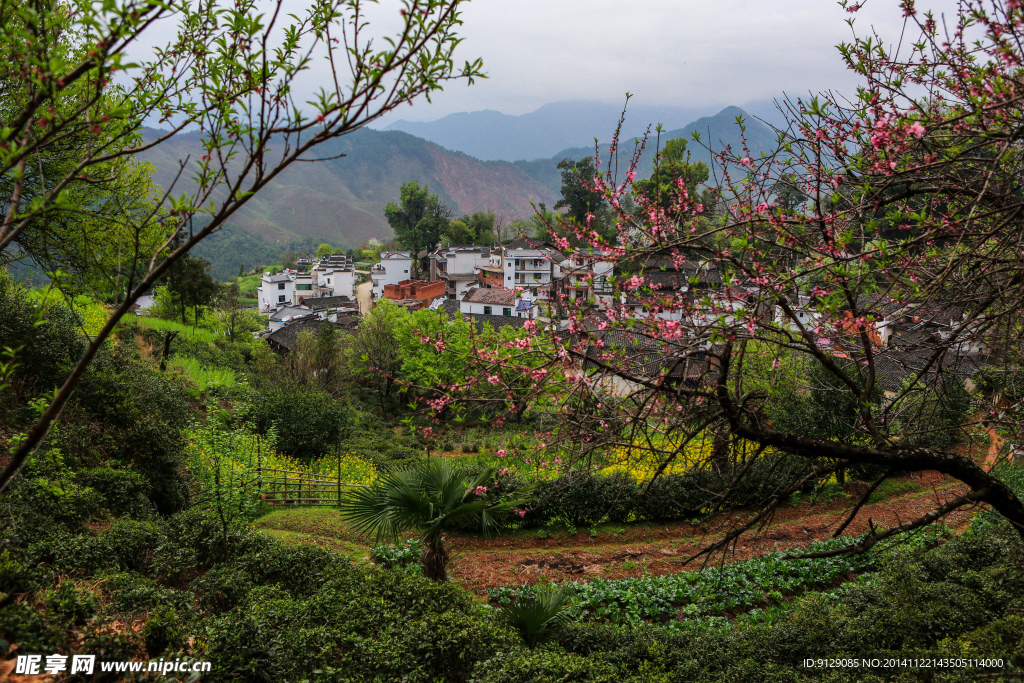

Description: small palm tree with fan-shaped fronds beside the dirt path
[341,458,529,581]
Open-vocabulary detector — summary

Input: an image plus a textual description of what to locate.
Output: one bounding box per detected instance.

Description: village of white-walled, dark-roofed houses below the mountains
[251,236,987,398]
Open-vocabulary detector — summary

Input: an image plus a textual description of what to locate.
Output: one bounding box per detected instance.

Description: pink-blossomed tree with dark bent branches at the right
[434,0,1024,553]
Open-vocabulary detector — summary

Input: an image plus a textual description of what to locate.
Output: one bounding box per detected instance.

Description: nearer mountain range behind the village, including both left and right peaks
[140,108,774,274]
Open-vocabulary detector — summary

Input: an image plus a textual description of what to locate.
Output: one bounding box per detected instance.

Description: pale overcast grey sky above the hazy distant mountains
[366,0,953,124]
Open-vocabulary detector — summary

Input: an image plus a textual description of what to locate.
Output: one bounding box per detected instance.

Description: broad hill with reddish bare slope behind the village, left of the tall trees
[141,128,557,252]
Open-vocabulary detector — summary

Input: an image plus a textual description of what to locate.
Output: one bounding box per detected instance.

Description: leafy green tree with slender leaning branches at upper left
[0,0,481,489]
